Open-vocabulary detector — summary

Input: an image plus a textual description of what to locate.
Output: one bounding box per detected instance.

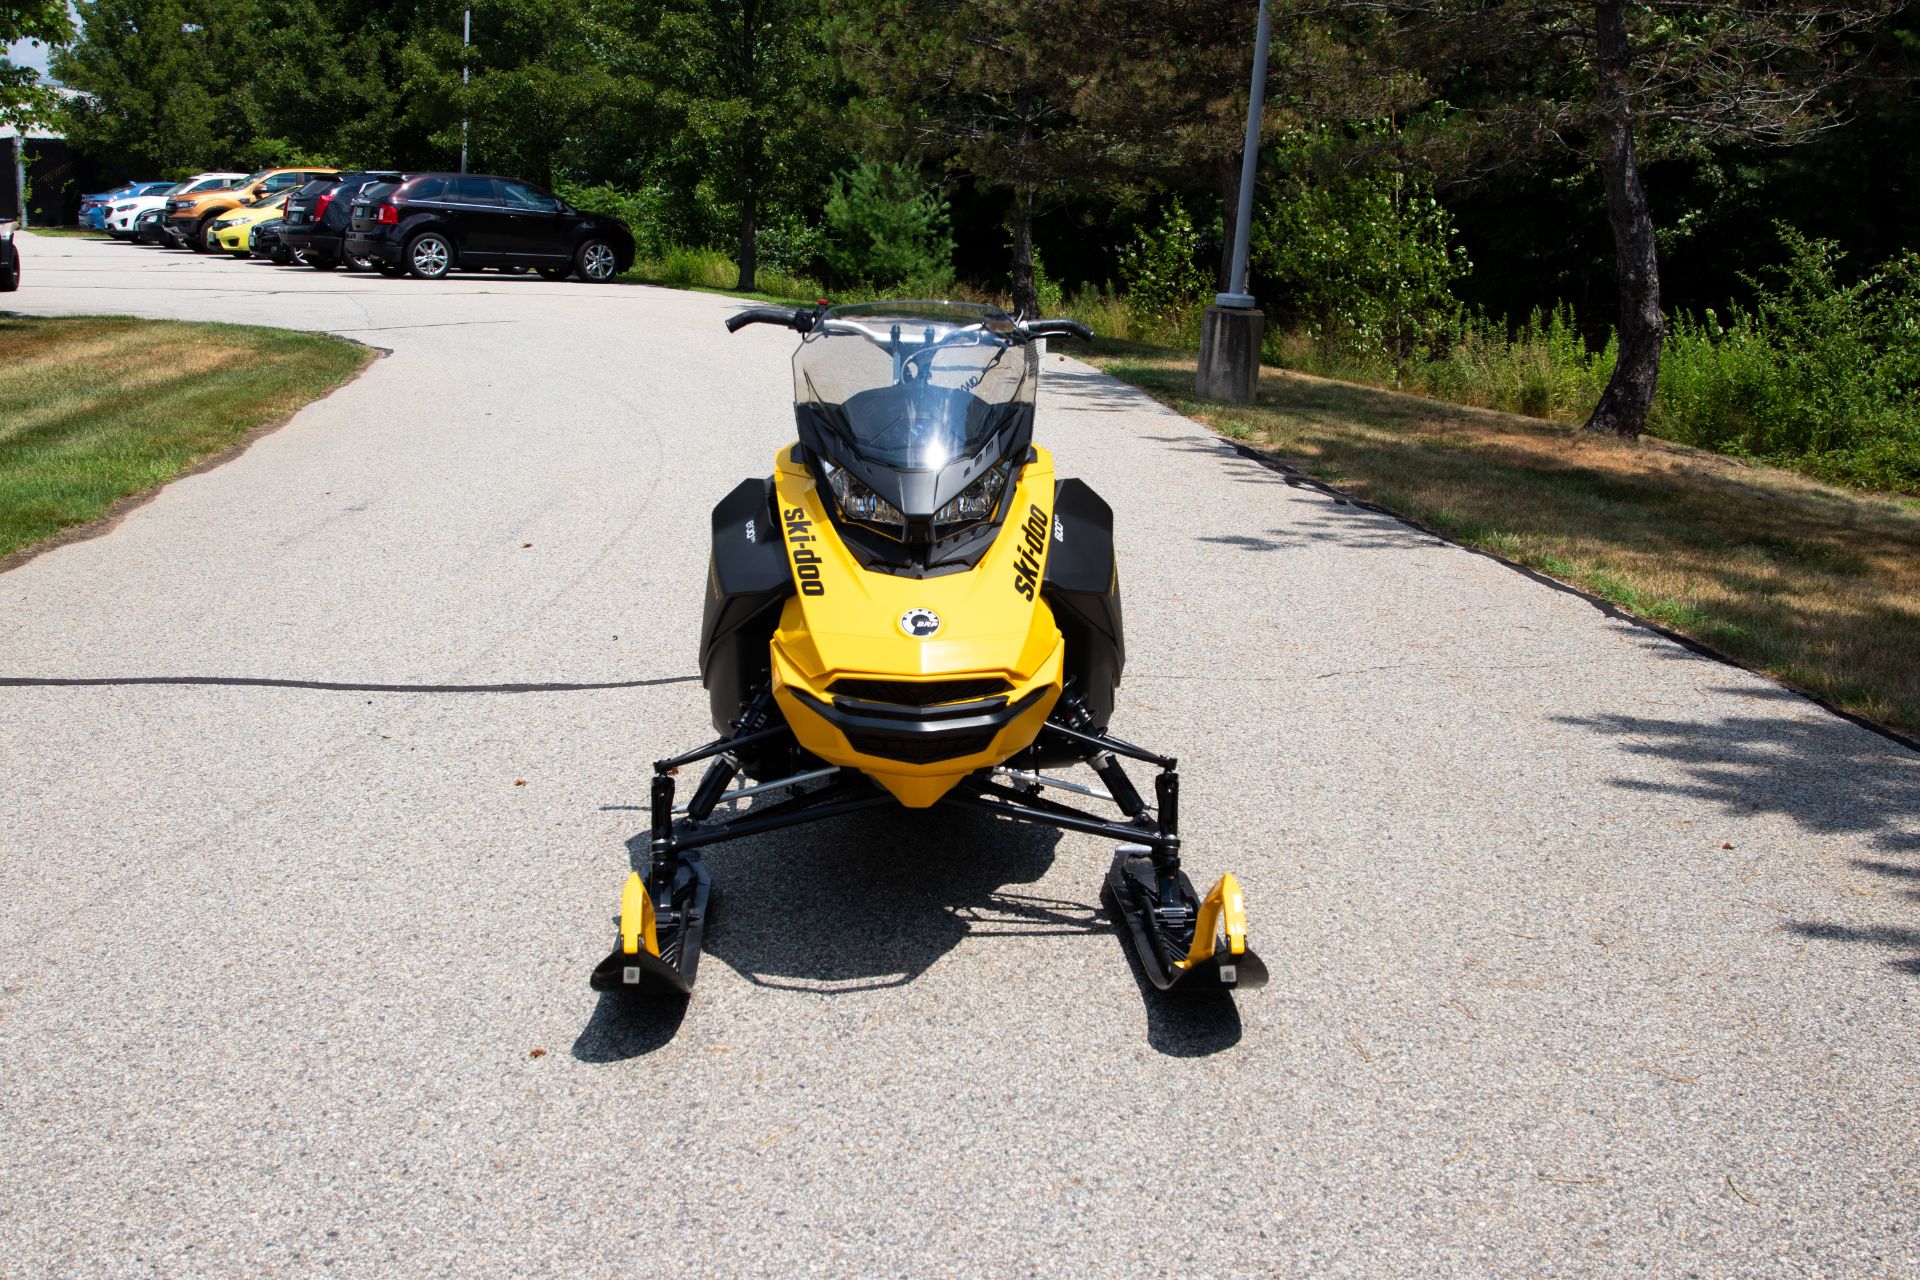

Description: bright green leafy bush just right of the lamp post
[1254,155,1469,376]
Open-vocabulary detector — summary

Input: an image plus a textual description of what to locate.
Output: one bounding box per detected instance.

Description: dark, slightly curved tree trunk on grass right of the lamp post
[1586,0,1667,438]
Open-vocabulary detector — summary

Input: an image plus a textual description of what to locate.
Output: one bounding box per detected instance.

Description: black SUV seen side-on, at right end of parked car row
[346,173,634,284]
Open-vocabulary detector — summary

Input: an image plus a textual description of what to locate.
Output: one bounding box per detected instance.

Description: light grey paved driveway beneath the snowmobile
[0,238,1920,1276]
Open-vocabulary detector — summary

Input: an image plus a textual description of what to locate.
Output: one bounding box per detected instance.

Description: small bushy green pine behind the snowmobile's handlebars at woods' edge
[826,161,954,286]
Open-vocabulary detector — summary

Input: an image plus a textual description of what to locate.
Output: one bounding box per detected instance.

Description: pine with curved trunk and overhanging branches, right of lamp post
[1374,0,1897,436]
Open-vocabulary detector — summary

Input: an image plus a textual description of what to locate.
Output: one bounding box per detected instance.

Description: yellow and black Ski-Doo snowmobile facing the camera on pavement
[593,301,1267,994]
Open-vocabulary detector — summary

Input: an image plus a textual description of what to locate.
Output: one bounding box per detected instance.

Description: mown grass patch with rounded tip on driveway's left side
[0,315,374,562]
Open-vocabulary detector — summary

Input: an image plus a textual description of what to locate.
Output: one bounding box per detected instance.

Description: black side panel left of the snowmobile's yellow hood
[701,478,793,733]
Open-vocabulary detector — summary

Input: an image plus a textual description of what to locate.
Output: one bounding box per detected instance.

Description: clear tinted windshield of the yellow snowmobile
[793,301,1035,472]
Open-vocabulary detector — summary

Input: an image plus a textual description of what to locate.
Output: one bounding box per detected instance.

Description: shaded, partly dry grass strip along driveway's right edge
[1091,342,1920,733]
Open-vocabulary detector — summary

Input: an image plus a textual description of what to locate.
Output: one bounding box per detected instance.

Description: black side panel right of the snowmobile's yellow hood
[1041,480,1127,729]
